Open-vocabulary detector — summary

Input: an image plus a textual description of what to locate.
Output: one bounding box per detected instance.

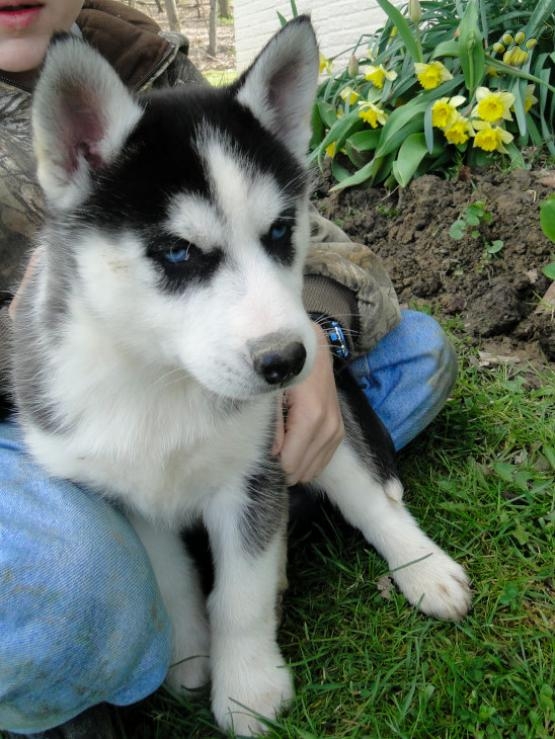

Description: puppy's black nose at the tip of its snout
[249,334,306,385]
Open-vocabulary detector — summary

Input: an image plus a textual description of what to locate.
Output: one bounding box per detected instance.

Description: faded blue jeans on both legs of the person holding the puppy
[0,311,456,733]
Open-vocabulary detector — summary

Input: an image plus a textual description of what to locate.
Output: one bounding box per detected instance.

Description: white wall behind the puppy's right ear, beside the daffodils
[233,0,401,71]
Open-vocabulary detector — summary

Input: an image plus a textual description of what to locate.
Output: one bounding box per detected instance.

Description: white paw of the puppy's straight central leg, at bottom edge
[212,648,294,736]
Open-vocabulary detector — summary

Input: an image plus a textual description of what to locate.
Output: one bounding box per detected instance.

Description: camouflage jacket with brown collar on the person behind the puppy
[0,0,399,408]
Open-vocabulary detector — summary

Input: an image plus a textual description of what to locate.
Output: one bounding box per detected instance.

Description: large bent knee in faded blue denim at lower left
[0,450,171,733]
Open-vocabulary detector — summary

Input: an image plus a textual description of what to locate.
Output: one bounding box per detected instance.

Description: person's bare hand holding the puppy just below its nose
[272,324,345,485]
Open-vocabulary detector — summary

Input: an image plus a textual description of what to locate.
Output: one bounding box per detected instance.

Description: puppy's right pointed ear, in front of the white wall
[237,15,319,159]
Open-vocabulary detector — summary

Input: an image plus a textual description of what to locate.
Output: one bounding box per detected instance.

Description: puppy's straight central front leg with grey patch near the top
[205,475,293,736]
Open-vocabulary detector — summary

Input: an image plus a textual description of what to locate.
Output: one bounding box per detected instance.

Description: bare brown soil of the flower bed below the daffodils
[316,170,555,363]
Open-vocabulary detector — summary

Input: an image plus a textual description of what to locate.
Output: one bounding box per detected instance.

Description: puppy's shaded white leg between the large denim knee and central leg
[130,516,210,692]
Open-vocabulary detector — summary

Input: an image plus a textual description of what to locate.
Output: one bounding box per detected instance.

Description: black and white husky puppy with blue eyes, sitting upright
[10,17,470,735]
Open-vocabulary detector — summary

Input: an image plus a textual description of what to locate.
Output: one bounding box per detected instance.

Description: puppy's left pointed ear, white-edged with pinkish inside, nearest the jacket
[32,34,142,210]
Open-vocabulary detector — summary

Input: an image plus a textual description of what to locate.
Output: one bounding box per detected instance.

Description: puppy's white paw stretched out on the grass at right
[392,543,471,621]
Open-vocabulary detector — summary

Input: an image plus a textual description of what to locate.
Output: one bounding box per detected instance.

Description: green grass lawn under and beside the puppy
[122,332,555,739]
